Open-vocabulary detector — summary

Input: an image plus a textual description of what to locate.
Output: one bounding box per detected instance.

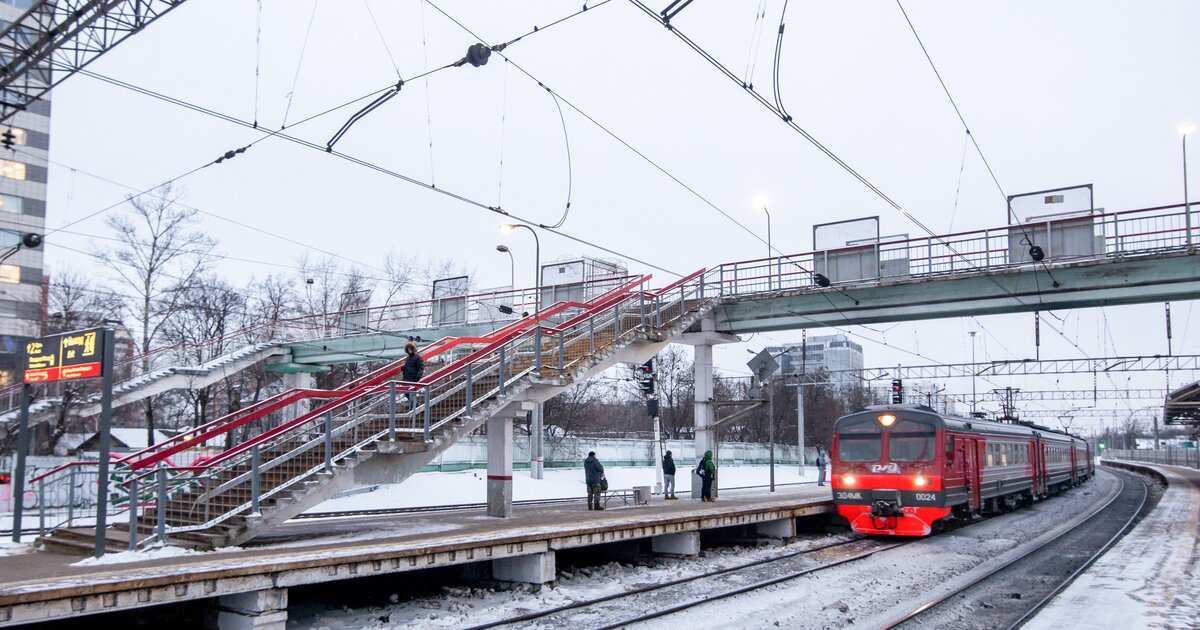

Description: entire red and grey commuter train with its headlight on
[830,404,1096,536]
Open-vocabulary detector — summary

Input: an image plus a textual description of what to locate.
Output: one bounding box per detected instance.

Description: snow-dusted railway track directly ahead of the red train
[468,538,919,630]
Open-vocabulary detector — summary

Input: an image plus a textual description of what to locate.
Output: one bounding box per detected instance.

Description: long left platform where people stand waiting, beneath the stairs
[0,485,834,626]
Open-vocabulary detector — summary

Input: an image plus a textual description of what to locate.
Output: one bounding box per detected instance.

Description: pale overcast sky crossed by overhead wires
[32,0,1200,427]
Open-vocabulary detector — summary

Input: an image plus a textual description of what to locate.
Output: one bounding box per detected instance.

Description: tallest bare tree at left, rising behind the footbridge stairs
[98,185,216,444]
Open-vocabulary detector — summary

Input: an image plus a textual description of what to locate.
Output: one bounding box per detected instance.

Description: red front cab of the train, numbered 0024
[832,409,954,536]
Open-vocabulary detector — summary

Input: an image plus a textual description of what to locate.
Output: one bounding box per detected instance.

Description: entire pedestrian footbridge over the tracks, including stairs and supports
[11,199,1200,548]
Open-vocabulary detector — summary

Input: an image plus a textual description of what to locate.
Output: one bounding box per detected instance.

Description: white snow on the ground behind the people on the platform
[308,466,817,512]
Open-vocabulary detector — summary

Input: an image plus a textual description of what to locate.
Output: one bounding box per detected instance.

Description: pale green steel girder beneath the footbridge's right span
[715,251,1200,335]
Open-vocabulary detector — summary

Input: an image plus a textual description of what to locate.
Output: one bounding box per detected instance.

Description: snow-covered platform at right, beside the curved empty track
[1025,462,1200,630]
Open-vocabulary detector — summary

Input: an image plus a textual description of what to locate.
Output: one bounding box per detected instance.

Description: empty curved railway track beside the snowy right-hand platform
[884,473,1150,630]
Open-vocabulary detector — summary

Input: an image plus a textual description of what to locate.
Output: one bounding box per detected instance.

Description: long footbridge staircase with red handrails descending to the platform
[40,271,716,552]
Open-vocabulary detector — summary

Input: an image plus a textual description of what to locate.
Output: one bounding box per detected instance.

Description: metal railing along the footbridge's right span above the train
[706,204,1200,295]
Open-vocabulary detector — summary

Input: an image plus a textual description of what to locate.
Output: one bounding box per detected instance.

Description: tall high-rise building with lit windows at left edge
[0,0,50,384]
